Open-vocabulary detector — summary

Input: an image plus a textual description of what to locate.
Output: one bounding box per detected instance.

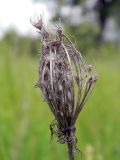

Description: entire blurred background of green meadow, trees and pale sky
[0,0,120,160]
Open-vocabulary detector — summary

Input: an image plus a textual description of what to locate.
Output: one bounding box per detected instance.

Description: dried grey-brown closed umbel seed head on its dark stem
[32,18,97,160]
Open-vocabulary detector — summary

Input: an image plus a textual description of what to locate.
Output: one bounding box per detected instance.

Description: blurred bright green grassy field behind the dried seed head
[0,39,120,160]
